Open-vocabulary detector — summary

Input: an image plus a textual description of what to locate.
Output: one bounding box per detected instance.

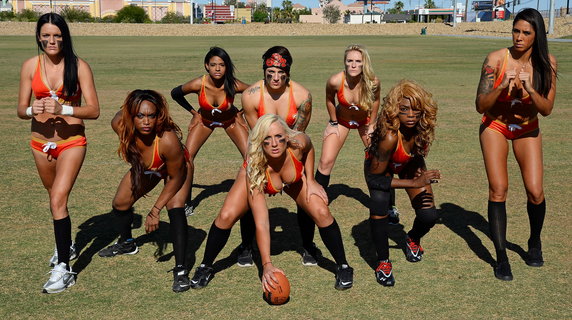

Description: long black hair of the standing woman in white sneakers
[36,12,78,97]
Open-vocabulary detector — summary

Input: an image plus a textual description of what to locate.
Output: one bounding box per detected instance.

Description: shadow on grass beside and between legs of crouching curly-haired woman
[352,219,407,270]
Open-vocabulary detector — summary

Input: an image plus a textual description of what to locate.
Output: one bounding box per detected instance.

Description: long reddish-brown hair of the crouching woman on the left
[117,89,183,198]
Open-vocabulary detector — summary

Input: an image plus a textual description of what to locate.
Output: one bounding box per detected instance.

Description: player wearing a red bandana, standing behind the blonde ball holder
[241,46,319,266]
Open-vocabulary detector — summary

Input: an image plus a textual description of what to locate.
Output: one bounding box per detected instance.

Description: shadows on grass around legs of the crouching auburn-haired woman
[73,212,206,274]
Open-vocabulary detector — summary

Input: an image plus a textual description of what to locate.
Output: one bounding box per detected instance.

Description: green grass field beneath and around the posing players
[0,36,572,319]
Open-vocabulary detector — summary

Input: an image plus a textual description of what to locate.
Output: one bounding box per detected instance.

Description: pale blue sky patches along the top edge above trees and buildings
[197,0,572,12]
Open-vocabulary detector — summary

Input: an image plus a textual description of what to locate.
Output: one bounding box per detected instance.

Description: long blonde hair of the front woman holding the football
[246,114,300,192]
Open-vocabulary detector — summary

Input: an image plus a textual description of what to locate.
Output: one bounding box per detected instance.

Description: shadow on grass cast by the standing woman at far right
[439,203,526,267]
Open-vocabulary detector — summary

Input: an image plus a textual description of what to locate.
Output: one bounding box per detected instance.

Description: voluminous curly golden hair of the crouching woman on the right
[366,79,437,157]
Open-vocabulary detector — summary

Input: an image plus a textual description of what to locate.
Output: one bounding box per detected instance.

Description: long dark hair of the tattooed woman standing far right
[512,8,556,96]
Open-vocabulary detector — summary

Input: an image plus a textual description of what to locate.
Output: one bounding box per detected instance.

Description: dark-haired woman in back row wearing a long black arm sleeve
[171,47,248,215]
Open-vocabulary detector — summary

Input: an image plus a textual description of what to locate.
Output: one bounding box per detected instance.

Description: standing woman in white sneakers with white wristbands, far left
[18,13,99,293]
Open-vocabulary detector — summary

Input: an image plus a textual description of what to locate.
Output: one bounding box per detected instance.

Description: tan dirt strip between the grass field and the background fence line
[0,16,572,38]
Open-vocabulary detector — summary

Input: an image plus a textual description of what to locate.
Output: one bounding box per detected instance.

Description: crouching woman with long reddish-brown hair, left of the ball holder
[98,89,190,292]
